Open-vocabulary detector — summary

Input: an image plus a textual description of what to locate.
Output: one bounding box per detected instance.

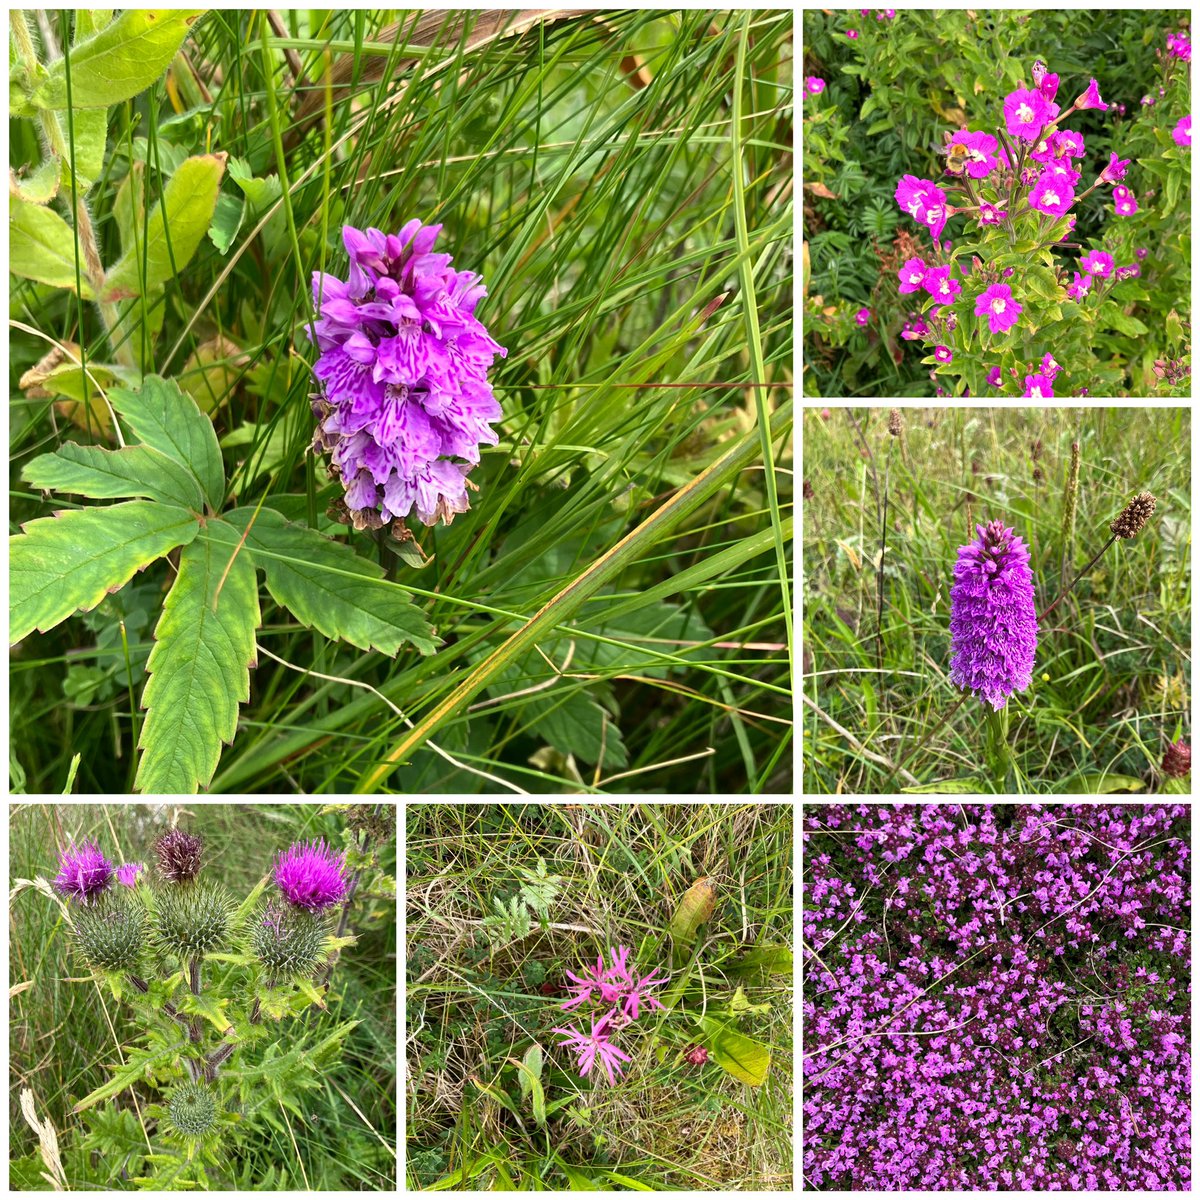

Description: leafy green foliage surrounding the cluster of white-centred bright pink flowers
[804,8,1190,396]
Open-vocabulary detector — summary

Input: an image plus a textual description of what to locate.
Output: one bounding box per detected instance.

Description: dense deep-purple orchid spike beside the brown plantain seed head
[950,521,1038,709]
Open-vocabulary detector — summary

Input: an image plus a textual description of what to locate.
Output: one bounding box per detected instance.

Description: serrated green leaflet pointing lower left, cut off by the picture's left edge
[8,500,200,643]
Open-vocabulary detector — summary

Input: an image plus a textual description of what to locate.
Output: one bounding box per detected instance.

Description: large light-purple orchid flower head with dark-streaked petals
[308,220,508,529]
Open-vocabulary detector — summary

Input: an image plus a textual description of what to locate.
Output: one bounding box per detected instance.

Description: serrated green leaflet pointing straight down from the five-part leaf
[134,520,259,796]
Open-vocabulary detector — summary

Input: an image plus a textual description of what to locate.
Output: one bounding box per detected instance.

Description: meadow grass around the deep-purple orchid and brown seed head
[803,408,1192,794]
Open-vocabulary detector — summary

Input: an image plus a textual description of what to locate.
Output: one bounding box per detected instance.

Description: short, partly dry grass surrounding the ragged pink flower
[406,803,793,1192]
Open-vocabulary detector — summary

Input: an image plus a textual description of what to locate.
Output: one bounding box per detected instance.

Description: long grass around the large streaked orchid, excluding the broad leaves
[10,8,793,794]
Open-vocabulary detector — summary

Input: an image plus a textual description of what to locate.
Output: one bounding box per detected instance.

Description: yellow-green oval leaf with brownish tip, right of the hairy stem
[104,154,226,300]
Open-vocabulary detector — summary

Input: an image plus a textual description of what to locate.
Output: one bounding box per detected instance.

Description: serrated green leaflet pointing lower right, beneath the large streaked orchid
[227,508,437,655]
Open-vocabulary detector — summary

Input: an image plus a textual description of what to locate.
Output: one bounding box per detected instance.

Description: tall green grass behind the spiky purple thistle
[7,804,396,1192]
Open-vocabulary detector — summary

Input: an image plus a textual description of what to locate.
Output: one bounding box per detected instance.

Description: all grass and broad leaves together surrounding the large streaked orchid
[10,10,793,794]
